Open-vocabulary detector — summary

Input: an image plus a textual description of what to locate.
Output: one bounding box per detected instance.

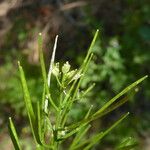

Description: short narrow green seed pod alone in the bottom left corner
[8,117,21,150]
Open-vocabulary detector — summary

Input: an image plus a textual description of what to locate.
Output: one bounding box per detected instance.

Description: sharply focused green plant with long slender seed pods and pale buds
[9,31,147,150]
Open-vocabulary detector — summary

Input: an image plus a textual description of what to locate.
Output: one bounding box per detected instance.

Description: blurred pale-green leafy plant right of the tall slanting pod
[82,38,127,102]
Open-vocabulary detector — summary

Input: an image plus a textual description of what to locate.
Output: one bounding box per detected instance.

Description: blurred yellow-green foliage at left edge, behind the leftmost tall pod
[0,52,42,125]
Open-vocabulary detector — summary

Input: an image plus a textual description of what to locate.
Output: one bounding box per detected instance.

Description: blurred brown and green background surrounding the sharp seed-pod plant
[0,0,150,150]
